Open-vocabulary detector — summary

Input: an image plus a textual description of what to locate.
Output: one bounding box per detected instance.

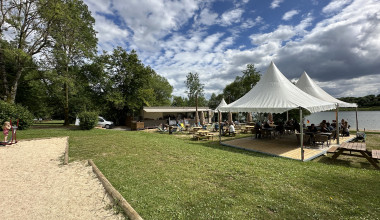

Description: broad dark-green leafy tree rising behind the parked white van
[86,47,173,124]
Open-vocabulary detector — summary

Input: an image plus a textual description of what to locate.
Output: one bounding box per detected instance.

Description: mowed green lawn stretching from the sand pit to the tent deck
[18,129,380,219]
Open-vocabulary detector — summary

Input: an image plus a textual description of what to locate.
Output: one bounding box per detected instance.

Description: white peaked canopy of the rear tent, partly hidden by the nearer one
[296,72,358,107]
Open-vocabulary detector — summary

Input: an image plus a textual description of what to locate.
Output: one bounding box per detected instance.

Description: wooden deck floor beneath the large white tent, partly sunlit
[222,134,355,161]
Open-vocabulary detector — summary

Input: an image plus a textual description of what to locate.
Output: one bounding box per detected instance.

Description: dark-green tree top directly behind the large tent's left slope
[223,64,261,103]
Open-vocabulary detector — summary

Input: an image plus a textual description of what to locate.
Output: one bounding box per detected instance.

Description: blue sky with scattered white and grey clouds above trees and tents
[84,0,380,98]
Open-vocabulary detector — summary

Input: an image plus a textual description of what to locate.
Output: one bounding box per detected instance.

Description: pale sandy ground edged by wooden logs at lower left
[0,138,124,219]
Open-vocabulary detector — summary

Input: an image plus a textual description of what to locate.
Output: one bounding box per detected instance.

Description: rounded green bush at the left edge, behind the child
[0,100,34,130]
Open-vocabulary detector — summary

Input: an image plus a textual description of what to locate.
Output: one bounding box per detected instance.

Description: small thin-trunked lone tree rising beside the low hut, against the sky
[185,72,204,124]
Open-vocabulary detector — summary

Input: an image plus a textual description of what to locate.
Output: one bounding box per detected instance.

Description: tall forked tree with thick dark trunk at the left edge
[0,0,54,103]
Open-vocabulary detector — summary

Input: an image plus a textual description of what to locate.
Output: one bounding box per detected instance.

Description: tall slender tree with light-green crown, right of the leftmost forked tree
[43,0,97,125]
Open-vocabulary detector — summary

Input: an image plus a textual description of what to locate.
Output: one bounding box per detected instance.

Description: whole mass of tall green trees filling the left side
[0,0,173,125]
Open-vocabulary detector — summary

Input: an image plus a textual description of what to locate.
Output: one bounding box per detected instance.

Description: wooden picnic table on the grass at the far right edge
[332,142,380,170]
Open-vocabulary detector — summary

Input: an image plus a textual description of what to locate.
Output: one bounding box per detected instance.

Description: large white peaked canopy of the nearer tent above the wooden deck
[220,62,335,113]
